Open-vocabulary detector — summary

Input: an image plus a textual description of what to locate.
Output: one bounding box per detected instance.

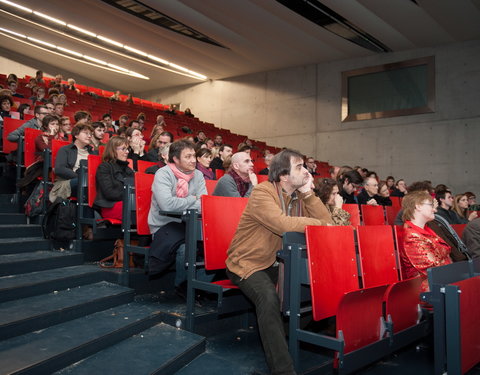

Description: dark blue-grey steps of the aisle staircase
[0,194,205,375]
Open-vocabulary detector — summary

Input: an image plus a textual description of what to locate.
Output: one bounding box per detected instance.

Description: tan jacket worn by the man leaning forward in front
[226,181,333,278]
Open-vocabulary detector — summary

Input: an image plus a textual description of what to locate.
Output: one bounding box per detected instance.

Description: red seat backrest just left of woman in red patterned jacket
[357,225,399,288]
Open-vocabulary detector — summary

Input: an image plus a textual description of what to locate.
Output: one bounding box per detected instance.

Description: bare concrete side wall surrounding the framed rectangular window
[142,41,480,192]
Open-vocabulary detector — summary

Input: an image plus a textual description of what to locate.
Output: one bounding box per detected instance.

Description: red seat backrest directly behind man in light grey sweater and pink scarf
[135,172,155,235]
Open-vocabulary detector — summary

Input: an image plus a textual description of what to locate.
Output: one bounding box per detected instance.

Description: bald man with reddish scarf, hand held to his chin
[212,152,258,198]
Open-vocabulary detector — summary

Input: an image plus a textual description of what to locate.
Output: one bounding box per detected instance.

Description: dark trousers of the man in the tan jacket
[227,267,295,375]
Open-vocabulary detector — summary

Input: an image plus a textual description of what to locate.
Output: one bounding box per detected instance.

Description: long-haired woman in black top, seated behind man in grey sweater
[94,136,134,220]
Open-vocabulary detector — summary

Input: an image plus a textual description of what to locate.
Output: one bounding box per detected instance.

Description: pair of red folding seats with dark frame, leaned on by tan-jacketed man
[280,226,427,373]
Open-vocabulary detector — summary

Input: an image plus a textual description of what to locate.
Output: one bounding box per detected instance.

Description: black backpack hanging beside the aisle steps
[42,198,77,241]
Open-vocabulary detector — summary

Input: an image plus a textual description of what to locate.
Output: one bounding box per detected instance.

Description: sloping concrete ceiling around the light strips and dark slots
[0,0,480,92]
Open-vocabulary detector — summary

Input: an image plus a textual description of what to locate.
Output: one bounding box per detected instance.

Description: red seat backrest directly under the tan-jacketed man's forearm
[305,226,359,320]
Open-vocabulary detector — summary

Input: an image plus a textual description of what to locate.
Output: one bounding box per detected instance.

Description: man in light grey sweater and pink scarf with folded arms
[148,140,207,296]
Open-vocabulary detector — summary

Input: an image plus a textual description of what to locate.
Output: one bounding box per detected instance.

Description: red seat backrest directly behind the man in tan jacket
[201,195,248,270]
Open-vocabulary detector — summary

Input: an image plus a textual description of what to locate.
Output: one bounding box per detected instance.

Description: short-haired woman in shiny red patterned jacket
[400,191,452,292]
